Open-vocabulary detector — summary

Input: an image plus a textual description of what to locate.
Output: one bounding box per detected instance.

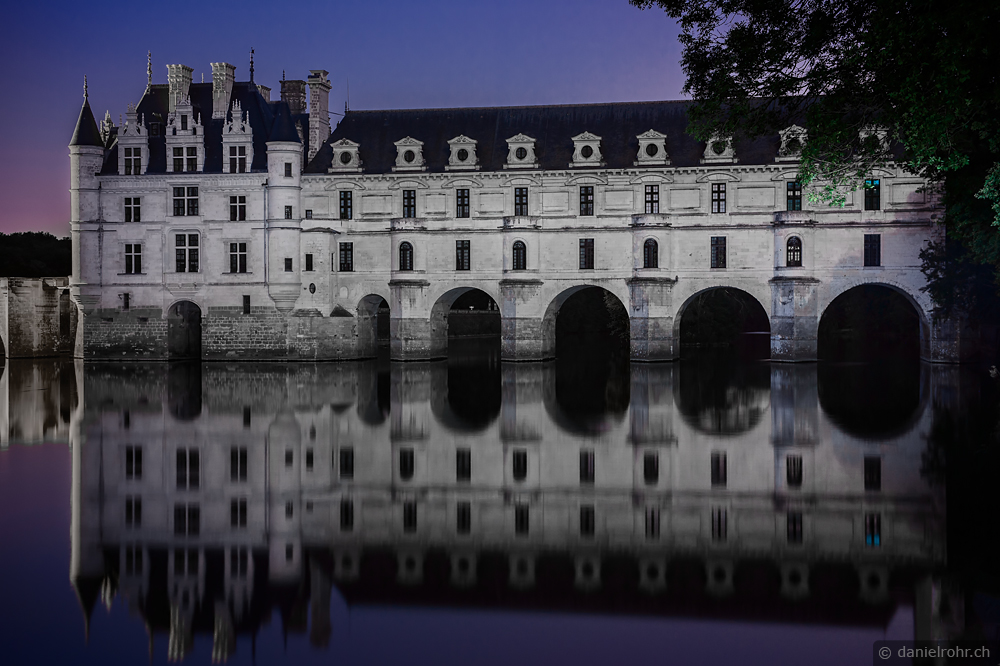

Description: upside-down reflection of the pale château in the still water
[0,355,954,660]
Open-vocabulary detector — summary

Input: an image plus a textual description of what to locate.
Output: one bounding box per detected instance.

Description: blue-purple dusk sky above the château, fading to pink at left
[0,0,684,236]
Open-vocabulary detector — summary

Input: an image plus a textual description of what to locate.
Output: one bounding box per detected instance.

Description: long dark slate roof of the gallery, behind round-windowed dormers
[306,101,781,173]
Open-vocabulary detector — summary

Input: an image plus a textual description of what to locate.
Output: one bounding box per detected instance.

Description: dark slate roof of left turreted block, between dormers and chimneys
[98,82,309,175]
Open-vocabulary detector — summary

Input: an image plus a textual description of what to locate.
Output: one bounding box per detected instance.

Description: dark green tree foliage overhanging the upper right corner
[630,0,1000,250]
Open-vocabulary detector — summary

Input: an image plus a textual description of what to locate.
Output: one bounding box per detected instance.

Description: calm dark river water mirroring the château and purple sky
[0,344,996,665]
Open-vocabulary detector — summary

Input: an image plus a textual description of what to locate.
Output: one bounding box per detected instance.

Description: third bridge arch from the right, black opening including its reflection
[543,286,631,434]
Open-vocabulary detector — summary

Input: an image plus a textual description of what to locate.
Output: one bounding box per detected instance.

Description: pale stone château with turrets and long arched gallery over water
[70,55,966,361]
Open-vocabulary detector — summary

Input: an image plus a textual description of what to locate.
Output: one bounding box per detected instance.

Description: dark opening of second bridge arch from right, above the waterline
[676,287,771,360]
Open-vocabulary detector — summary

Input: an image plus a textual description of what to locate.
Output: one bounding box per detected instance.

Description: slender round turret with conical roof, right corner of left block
[267,103,302,313]
